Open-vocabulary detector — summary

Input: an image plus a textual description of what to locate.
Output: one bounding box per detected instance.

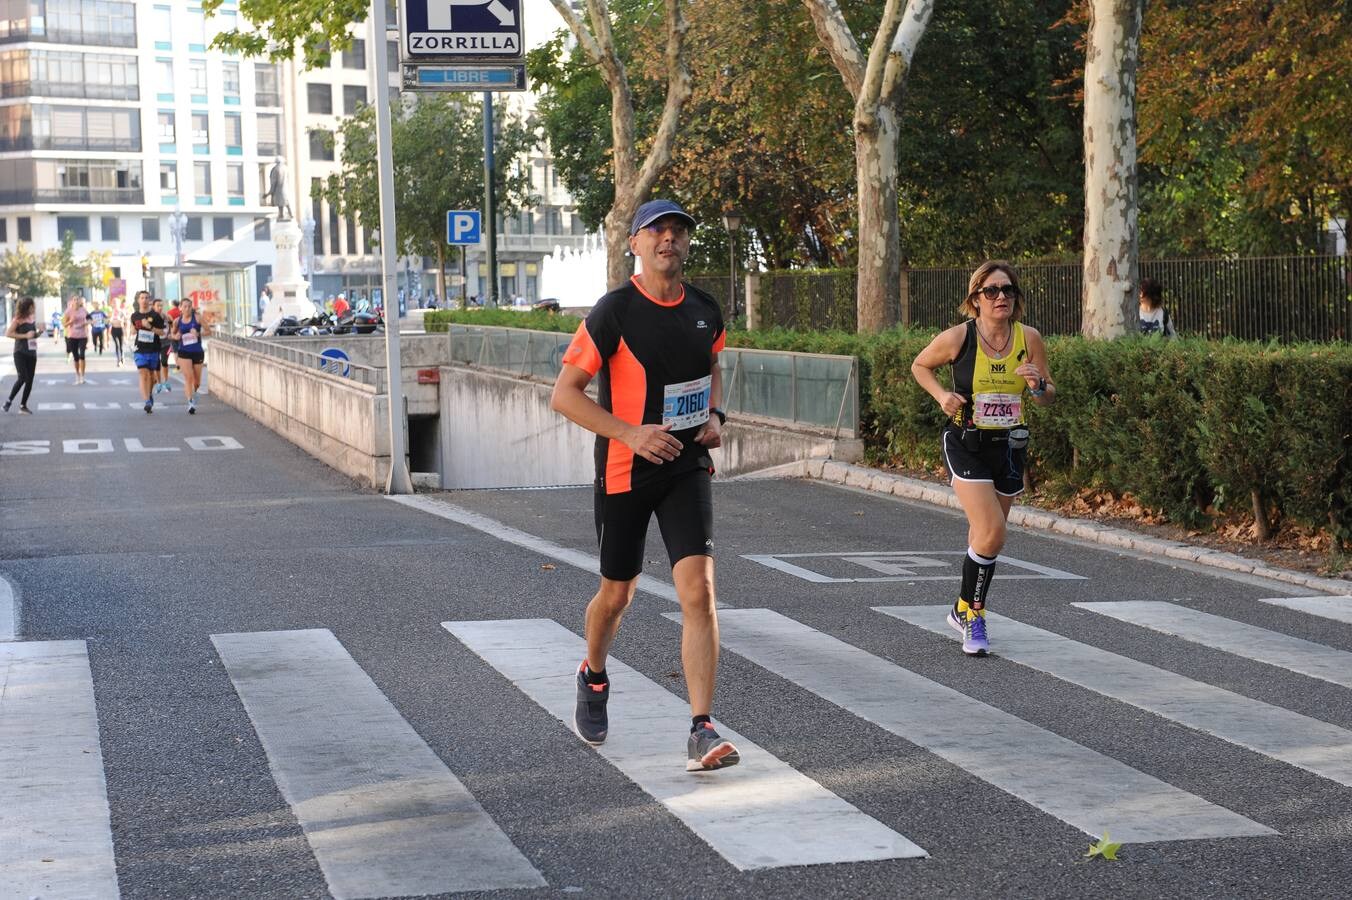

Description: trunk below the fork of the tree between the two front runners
[854,107,902,334]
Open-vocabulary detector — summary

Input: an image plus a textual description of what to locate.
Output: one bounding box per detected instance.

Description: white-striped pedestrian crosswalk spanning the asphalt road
[0,599,1352,897]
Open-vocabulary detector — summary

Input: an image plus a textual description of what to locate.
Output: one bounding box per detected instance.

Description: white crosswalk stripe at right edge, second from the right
[1072,600,1352,688]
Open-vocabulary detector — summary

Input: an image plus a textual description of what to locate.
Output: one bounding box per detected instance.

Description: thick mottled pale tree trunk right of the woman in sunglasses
[1082,0,1144,339]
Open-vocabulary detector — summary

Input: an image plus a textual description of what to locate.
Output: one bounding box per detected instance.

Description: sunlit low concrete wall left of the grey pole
[207,342,392,488]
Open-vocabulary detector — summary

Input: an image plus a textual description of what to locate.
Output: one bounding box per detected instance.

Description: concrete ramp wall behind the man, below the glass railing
[441,366,863,488]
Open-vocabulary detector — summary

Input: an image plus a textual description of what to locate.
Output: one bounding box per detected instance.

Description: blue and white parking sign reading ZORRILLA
[399,0,526,64]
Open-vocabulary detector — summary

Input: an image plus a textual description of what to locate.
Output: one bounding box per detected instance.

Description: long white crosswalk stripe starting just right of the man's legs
[718,609,1272,842]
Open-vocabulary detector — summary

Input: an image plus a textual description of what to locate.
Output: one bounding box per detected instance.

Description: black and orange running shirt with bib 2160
[564,278,725,493]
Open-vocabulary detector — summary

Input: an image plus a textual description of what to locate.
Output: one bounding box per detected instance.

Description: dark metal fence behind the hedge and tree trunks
[757,255,1352,341]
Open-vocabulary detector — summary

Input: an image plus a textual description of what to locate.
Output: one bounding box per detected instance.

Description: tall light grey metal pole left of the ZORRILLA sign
[366,0,414,493]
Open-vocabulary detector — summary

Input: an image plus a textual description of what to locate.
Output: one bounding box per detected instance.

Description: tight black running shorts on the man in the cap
[595,469,714,581]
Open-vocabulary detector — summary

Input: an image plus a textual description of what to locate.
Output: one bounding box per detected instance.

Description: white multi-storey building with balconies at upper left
[0,0,284,301]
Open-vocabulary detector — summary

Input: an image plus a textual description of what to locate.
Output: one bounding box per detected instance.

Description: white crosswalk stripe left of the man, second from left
[211,630,545,900]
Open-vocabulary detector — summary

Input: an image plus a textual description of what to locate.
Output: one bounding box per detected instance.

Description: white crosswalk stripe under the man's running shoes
[442,619,925,870]
